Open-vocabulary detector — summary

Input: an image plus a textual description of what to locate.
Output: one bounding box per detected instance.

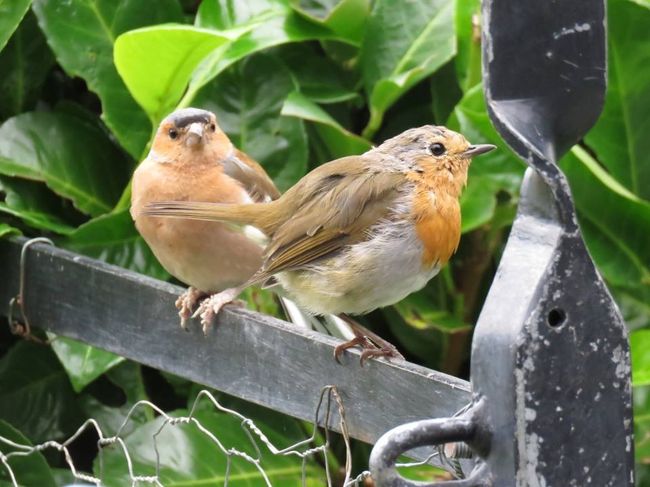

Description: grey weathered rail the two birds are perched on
[0,239,470,456]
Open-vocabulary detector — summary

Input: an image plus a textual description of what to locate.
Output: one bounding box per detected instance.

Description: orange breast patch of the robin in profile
[409,175,460,267]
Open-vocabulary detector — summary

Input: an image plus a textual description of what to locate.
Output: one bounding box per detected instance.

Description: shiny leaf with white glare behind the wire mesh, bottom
[95,410,325,487]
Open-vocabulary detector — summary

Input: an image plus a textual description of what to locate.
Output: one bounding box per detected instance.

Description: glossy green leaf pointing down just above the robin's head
[359,0,456,139]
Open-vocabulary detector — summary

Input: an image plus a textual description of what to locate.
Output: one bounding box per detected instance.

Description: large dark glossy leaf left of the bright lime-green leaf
[34,0,181,159]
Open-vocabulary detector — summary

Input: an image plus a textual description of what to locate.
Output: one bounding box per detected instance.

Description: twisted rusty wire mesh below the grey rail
[0,385,464,487]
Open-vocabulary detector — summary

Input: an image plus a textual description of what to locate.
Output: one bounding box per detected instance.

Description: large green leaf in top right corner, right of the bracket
[585,0,650,200]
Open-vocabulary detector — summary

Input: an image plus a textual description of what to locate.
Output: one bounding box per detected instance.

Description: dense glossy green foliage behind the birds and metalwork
[0,0,650,485]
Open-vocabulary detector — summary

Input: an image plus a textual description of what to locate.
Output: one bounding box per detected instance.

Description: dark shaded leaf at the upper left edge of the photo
[0,7,54,120]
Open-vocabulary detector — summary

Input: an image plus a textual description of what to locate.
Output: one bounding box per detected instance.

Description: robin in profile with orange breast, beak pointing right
[144,125,495,358]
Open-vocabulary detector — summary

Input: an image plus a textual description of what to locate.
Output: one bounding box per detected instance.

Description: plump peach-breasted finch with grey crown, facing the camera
[131,108,280,327]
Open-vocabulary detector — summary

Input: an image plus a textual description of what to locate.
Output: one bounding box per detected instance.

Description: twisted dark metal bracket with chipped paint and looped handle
[371,0,634,487]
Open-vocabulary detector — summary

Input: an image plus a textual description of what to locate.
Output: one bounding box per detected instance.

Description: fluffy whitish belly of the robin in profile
[277,217,439,314]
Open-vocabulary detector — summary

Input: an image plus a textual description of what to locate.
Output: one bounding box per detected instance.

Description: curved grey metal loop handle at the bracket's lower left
[370,415,482,487]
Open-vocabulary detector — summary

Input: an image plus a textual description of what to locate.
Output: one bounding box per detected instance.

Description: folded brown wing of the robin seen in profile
[244,168,403,284]
